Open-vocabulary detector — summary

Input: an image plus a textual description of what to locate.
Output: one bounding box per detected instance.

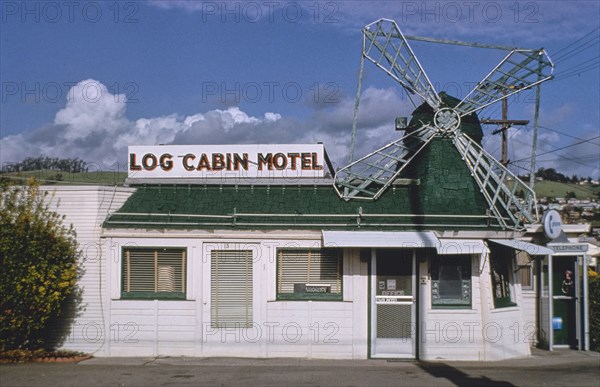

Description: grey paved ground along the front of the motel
[0,350,600,387]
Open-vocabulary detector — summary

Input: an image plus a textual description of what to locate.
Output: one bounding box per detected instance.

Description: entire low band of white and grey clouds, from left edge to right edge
[0,80,599,177]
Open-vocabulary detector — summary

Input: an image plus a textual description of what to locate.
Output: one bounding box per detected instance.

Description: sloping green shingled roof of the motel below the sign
[104,179,496,230]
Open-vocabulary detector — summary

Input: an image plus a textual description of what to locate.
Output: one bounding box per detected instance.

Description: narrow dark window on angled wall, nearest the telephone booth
[490,244,517,308]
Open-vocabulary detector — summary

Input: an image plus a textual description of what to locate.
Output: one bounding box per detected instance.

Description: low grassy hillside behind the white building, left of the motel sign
[0,169,127,185]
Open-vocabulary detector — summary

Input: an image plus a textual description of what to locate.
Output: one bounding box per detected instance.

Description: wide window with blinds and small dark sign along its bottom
[277,249,342,300]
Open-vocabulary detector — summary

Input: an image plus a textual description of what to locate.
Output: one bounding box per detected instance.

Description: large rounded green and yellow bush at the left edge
[0,180,79,350]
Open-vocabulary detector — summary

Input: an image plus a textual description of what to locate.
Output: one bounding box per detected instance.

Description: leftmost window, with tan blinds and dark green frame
[121,247,187,299]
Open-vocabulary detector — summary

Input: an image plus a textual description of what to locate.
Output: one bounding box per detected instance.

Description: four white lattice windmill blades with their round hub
[334,19,554,229]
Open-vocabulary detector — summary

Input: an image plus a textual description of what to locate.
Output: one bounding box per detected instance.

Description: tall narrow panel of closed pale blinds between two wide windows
[210,250,252,328]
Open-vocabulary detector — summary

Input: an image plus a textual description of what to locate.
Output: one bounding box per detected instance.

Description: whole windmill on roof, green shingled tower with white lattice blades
[334,19,554,230]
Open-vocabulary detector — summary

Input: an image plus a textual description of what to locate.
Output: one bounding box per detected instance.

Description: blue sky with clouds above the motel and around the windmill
[0,1,600,178]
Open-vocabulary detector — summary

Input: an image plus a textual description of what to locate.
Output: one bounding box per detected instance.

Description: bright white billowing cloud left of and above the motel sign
[0,79,281,168]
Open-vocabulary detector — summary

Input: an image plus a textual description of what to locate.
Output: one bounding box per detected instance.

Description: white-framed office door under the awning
[371,249,416,358]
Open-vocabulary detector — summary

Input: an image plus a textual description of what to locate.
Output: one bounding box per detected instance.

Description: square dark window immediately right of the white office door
[431,255,471,308]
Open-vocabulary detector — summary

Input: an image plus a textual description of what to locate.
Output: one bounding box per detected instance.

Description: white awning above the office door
[323,230,439,248]
